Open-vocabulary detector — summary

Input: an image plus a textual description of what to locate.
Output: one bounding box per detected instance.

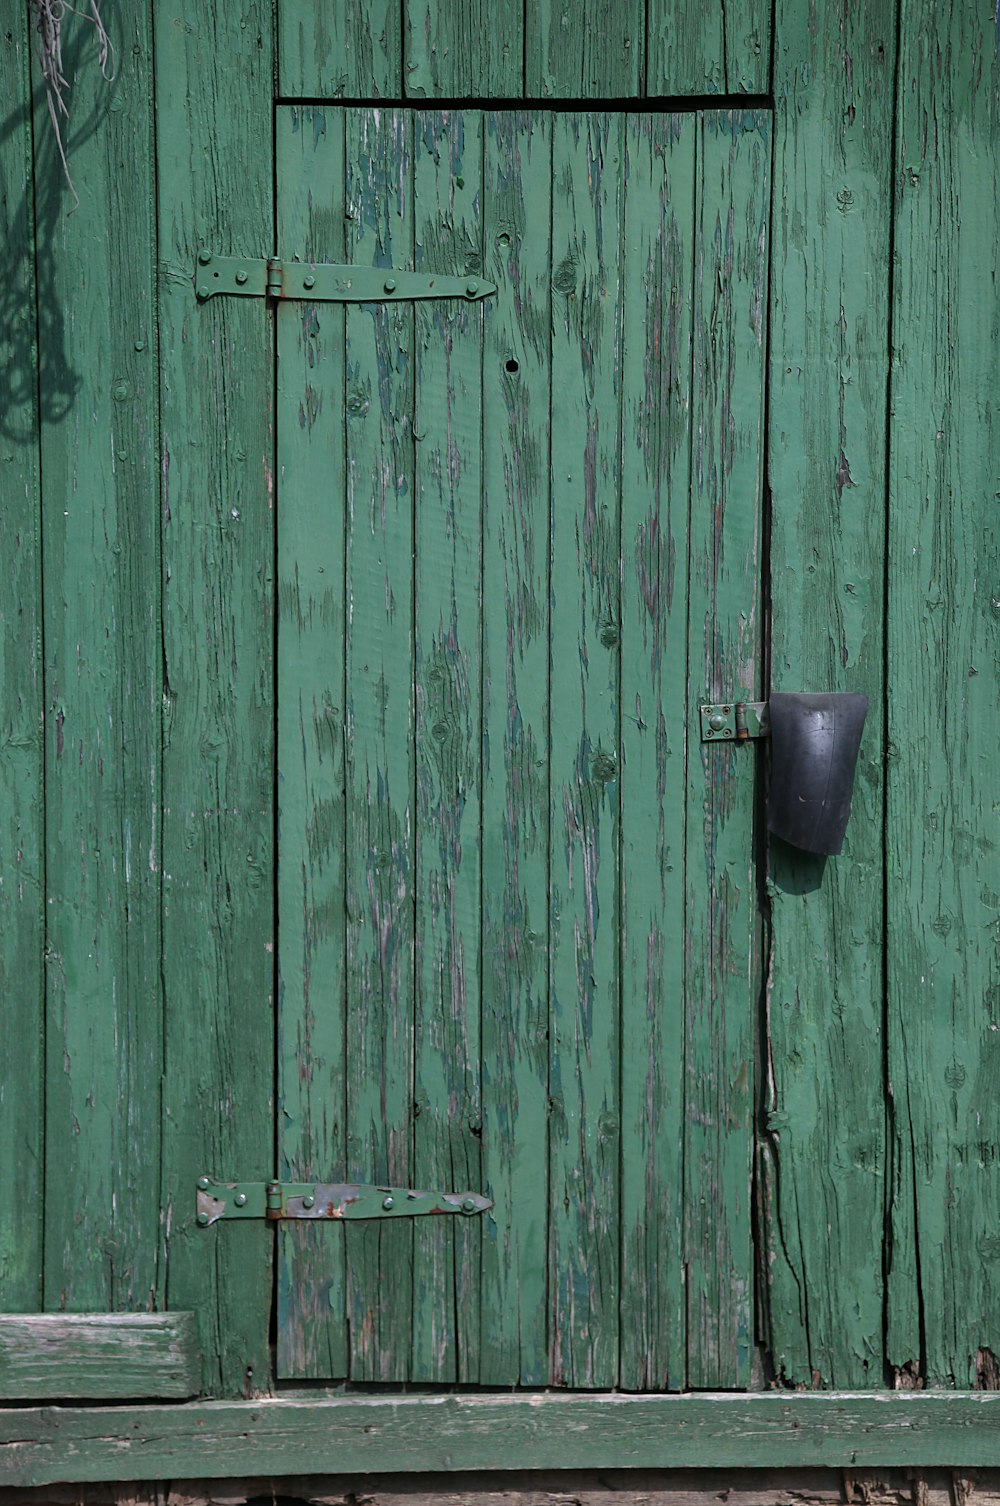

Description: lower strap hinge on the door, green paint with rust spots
[197,1176,492,1229]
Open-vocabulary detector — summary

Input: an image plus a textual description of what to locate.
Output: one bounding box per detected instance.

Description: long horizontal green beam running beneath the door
[13,1392,1000,1486]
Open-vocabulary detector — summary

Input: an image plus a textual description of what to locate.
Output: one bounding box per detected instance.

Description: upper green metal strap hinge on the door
[194,252,497,303]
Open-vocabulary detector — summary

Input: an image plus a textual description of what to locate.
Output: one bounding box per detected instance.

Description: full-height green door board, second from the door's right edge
[620,114,696,1390]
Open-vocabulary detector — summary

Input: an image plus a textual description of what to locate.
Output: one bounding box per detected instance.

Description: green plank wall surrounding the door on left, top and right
[0,0,1000,1395]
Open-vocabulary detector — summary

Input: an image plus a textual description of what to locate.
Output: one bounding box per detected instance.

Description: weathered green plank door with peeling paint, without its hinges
[276,107,770,1390]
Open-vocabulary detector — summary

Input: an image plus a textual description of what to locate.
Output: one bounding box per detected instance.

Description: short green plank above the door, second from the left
[404,0,524,99]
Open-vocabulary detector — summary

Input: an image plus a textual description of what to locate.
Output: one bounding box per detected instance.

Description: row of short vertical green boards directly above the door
[277,0,771,102]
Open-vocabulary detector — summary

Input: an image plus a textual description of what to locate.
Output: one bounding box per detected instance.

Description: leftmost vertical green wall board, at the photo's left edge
[0,8,43,1312]
